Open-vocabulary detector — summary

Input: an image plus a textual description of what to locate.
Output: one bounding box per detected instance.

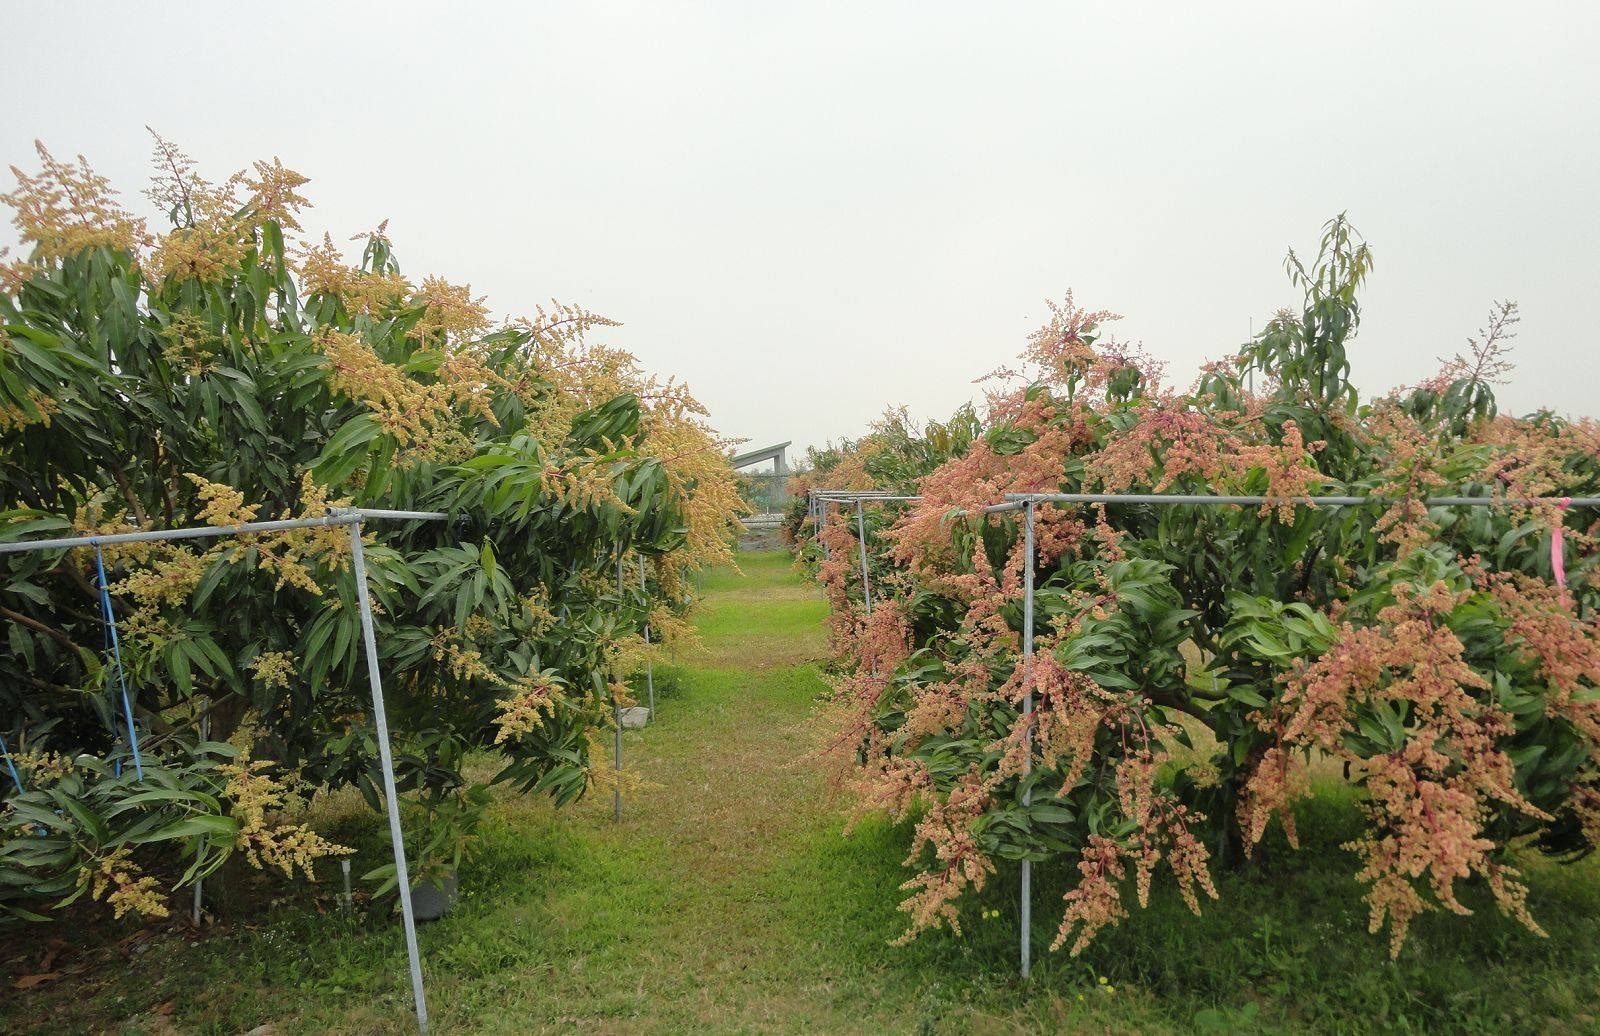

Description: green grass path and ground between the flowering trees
[9,555,1600,1033]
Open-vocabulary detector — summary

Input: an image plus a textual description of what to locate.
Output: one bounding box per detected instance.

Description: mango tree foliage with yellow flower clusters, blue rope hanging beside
[0,141,739,916]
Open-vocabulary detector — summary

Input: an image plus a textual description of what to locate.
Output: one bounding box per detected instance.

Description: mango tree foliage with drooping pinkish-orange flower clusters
[802,217,1600,953]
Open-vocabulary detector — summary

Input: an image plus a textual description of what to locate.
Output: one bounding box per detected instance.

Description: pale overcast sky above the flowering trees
[0,0,1600,457]
